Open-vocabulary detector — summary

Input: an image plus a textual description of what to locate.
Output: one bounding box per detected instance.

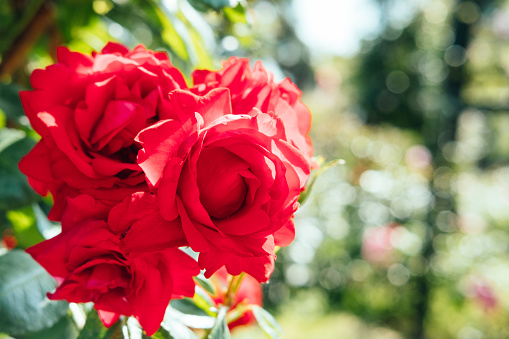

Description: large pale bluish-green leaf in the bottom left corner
[0,250,68,335]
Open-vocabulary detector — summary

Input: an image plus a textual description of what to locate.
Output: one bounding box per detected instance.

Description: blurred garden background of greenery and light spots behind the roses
[0,0,509,339]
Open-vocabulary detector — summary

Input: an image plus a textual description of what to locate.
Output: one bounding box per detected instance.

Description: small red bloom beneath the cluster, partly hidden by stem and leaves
[206,267,263,330]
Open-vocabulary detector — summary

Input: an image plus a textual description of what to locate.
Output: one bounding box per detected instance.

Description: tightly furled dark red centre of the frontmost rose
[197,147,249,219]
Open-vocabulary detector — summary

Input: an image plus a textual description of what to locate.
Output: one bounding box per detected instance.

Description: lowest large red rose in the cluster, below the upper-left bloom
[27,220,199,335]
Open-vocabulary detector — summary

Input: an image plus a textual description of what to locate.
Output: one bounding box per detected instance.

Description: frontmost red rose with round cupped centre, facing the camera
[109,89,309,282]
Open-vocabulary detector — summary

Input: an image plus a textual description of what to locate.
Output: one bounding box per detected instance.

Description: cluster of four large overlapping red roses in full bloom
[19,43,313,334]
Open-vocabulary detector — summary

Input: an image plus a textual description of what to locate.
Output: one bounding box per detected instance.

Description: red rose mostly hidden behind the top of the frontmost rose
[191,57,316,166]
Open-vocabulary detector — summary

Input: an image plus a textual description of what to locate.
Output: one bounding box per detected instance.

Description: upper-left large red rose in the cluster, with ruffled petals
[19,43,186,220]
